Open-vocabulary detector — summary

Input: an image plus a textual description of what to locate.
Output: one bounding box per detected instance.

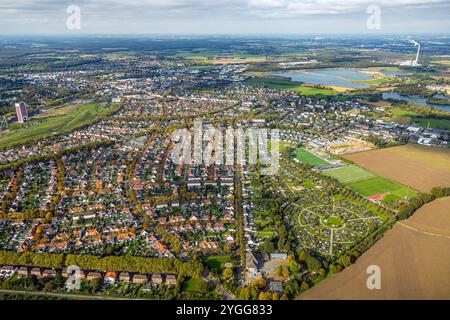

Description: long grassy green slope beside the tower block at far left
[0,103,109,149]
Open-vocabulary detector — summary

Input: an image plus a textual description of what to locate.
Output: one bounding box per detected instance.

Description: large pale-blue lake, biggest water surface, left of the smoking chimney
[272,69,372,89]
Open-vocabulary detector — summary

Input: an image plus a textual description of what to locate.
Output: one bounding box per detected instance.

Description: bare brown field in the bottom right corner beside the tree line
[299,197,450,300]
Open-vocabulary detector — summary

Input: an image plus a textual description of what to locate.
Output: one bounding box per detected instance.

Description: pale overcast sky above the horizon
[0,0,450,35]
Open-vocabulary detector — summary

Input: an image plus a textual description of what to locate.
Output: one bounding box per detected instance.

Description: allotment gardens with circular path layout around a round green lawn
[289,198,382,256]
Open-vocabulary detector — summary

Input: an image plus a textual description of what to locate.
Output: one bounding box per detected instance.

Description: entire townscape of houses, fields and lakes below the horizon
[0,1,450,300]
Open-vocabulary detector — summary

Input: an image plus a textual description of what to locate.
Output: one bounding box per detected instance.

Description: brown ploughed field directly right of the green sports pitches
[343,144,450,192]
